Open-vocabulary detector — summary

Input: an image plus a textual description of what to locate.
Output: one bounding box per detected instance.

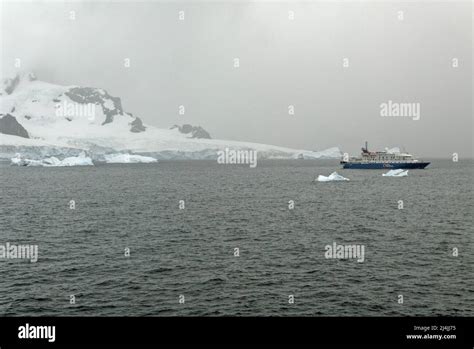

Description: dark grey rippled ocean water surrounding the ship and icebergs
[0,160,474,316]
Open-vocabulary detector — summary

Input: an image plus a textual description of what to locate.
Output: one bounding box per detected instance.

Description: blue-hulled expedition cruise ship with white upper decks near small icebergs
[341,142,430,169]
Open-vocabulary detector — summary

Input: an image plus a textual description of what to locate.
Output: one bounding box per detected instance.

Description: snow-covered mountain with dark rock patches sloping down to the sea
[0,73,341,159]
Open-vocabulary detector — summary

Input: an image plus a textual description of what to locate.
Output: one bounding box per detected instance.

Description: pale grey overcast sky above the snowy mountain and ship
[1,1,473,157]
